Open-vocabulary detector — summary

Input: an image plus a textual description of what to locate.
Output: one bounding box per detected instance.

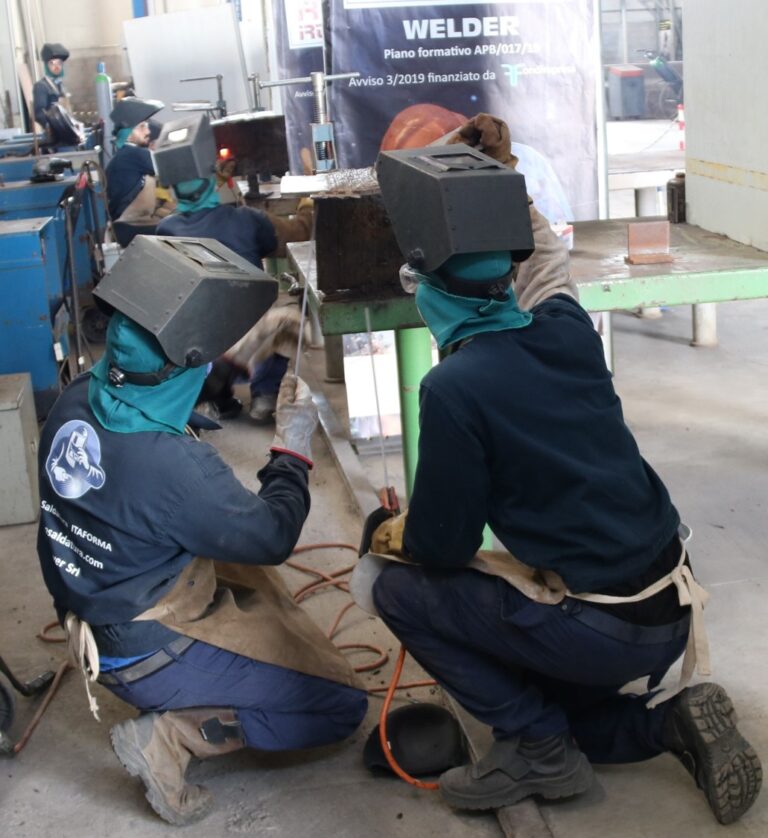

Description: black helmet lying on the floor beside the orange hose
[363,703,469,777]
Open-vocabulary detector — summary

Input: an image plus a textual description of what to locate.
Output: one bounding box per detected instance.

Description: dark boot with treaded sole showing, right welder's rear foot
[662,683,763,824]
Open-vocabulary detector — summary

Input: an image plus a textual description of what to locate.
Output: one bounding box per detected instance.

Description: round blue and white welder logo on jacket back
[45,419,107,498]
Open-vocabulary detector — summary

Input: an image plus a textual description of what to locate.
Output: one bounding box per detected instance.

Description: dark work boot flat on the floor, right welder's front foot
[440,733,593,809]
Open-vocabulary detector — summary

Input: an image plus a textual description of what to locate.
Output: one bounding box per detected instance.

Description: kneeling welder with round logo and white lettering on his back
[38,236,367,824]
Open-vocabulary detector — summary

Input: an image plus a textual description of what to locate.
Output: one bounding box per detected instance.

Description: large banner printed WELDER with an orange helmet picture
[326,0,599,222]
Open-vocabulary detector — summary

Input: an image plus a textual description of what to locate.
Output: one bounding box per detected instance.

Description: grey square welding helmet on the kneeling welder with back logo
[93,236,278,367]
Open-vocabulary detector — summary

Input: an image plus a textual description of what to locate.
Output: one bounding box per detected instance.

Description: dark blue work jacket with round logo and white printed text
[37,375,310,657]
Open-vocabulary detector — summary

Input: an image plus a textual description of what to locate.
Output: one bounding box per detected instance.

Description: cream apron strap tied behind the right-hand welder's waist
[568,536,712,707]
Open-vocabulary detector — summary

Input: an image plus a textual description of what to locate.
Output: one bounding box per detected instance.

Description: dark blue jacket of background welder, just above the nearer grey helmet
[157,204,277,268]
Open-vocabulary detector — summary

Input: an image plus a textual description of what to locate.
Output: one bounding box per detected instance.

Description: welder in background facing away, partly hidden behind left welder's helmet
[154,115,312,425]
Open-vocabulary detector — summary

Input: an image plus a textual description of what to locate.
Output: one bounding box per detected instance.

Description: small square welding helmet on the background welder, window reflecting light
[152,114,217,186]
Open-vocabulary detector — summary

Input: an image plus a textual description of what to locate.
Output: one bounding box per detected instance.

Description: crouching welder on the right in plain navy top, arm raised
[363,131,761,823]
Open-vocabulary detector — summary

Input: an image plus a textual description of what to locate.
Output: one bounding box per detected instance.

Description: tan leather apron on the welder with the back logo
[134,558,364,689]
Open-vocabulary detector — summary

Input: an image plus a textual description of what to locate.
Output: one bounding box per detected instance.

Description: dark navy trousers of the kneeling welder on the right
[373,564,687,763]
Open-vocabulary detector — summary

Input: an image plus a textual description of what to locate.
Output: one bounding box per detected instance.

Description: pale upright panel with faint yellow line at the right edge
[683,0,768,250]
